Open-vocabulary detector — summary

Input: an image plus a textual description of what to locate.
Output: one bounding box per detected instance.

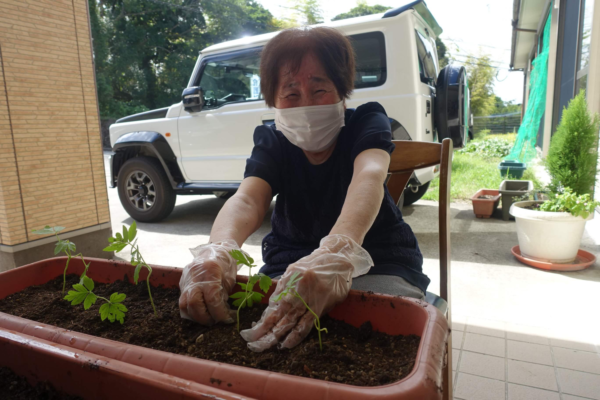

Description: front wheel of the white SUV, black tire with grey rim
[117,157,177,222]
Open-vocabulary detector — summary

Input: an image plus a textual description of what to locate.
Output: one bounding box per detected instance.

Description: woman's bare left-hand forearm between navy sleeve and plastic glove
[210,176,273,247]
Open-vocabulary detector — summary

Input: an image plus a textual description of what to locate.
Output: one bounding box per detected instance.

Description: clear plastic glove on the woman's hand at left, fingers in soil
[179,240,241,326]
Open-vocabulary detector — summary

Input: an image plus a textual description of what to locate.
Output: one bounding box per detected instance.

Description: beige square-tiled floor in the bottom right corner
[452,316,600,400]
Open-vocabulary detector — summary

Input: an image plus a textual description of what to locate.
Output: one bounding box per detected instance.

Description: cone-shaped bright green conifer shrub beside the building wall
[546,91,600,195]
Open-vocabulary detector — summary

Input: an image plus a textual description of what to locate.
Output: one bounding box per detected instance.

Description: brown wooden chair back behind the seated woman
[387,139,452,304]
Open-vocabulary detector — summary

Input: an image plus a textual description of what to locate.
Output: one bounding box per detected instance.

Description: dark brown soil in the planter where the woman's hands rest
[0,275,420,386]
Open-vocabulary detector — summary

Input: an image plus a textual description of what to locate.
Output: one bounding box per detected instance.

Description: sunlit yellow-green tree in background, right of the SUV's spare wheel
[464,54,496,117]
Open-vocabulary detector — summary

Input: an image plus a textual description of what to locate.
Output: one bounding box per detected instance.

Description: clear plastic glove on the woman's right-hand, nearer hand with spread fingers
[241,235,373,352]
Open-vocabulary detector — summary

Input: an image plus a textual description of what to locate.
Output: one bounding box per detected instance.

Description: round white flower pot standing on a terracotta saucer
[510,201,594,264]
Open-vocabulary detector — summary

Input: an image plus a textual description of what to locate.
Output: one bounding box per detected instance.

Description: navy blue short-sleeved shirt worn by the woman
[244,103,429,292]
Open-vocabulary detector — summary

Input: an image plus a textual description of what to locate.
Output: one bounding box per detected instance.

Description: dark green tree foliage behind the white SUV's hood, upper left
[88,0,279,118]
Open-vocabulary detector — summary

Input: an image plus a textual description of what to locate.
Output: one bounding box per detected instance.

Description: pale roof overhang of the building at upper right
[510,0,549,69]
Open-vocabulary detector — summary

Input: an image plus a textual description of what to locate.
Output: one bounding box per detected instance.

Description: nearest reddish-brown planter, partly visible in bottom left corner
[0,328,253,400]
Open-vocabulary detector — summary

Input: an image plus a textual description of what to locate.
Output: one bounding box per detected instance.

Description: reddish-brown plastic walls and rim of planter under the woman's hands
[0,257,449,400]
